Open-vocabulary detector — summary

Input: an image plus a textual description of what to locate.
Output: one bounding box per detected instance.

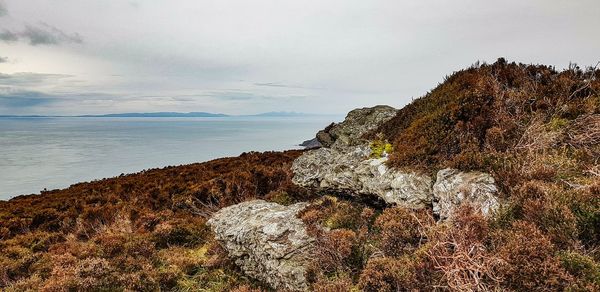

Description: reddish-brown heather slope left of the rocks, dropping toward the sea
[0,151,306,291]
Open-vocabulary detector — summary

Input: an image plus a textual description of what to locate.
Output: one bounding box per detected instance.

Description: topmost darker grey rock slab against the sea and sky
[317,105,398,148]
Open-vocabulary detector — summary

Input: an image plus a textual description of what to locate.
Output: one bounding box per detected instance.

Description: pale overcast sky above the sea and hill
[0,0,600,115]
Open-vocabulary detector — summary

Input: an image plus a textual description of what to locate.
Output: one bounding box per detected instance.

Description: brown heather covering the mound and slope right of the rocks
[303,59,600,291]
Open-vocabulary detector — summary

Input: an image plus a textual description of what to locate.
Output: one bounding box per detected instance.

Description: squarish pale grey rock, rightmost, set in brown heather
[433,168,500,220]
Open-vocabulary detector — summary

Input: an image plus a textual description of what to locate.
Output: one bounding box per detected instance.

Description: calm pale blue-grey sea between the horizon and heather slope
[0,116,341,200]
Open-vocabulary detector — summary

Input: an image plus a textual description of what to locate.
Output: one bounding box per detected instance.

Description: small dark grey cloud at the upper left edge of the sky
[0,23,83,46]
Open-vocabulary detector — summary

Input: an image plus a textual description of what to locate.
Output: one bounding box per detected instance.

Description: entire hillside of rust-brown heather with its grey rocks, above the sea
[0,59,600,291]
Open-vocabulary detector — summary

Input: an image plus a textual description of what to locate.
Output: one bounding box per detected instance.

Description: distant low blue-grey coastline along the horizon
[0,112,334,118]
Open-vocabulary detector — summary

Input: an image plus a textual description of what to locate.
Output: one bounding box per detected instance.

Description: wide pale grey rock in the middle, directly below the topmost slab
[292,145,432,209]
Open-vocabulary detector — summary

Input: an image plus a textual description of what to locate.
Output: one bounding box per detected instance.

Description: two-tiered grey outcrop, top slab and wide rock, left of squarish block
[292,105,432,209]
